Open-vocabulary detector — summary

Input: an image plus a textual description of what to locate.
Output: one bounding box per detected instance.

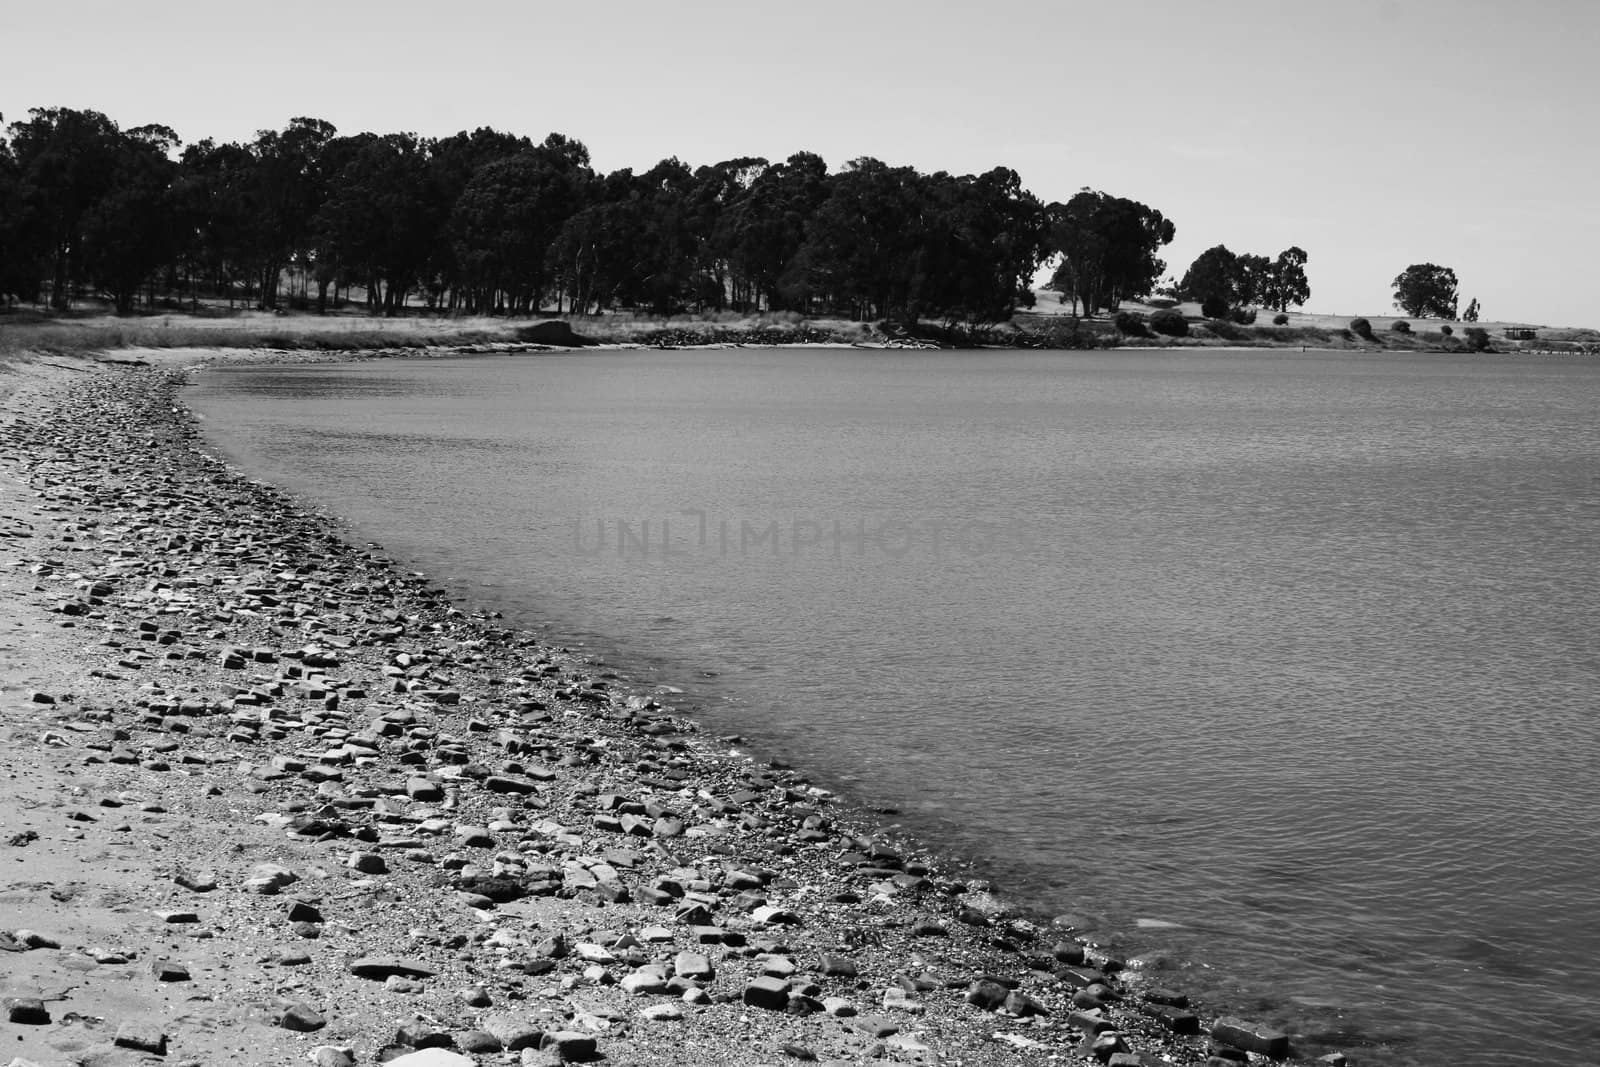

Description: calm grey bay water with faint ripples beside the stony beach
[187,350,1600,1065]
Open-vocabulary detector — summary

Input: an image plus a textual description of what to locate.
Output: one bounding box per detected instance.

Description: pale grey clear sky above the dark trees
[0,0,1600,326]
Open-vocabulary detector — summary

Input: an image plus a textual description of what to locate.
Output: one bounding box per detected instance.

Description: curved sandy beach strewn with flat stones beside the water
[0,357,1324,1067]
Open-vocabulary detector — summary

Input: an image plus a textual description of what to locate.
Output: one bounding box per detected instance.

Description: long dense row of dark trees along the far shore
[0,107,1203,323]
